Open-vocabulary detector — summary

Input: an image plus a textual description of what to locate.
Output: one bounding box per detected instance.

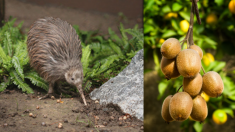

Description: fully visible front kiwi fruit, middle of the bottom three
[169,92,193,121]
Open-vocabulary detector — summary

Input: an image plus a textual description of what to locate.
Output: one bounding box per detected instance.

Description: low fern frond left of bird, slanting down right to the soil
[10,70,34,93]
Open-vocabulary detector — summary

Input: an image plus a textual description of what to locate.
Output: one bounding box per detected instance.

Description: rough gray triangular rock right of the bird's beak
[90,49,144,120]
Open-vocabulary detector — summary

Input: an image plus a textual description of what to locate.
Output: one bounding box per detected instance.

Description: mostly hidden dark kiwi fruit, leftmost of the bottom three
[161,95,174,123]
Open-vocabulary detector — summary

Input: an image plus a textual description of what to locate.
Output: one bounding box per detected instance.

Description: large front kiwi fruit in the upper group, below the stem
[176,49,201,78]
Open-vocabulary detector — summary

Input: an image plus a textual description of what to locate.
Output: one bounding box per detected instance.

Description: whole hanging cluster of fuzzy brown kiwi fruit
[161,38,224,123]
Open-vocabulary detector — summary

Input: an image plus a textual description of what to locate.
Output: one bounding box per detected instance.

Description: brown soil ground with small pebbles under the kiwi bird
[0,89,143,132]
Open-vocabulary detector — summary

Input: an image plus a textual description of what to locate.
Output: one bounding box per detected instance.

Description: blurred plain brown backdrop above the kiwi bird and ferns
[0,0,143,34]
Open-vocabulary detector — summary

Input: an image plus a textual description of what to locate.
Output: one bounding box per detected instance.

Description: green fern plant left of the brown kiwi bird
[0,19,48,93]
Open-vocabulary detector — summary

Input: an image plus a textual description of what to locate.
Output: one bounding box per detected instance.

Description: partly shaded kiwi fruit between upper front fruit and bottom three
[183,73,202,97]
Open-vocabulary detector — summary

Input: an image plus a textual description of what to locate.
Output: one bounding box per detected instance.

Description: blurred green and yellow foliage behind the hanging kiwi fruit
[143,0,235,132]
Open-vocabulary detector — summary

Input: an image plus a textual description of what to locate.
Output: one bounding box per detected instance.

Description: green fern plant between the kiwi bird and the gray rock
[74,24,143,90]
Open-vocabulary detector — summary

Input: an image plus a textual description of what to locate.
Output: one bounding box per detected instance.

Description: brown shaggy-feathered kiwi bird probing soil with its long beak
[27,17,87,105]
